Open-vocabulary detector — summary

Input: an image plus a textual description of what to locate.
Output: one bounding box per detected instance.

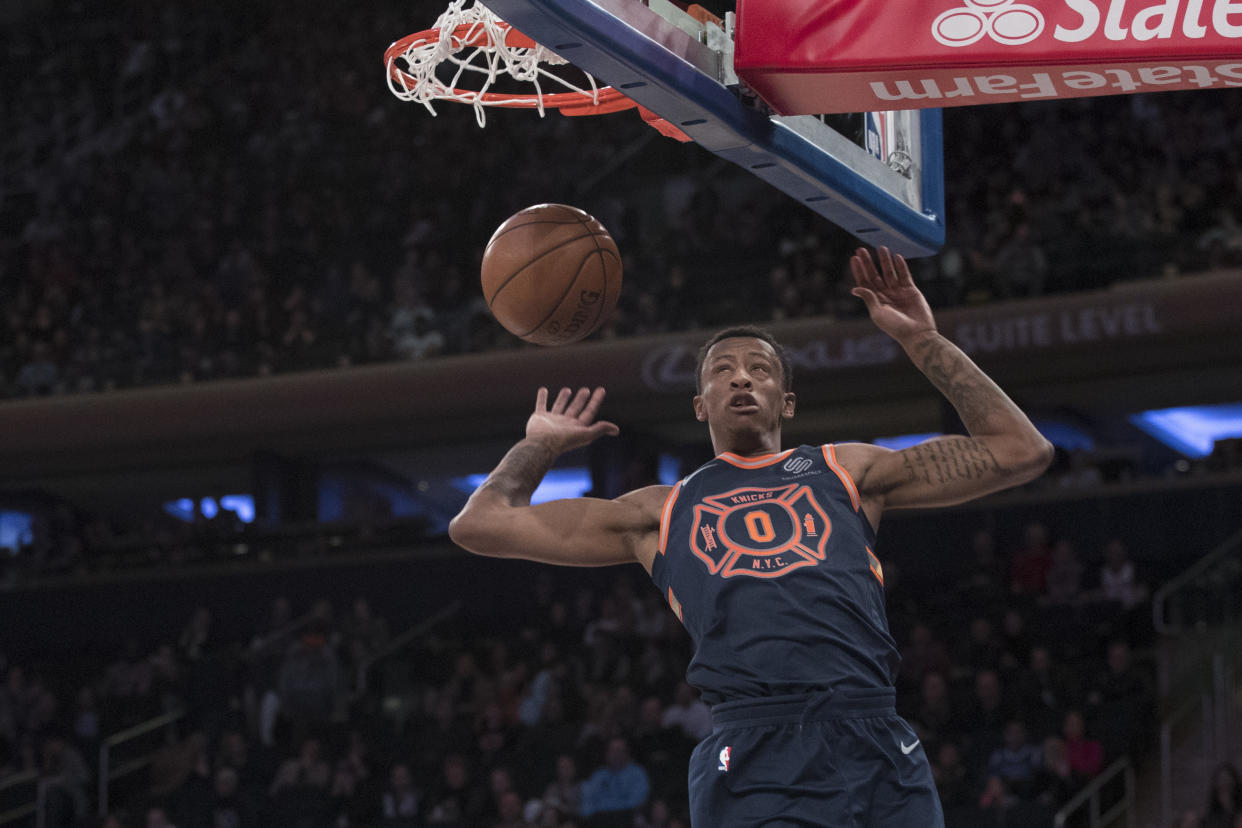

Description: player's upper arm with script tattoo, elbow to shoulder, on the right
[837,436,1051,509]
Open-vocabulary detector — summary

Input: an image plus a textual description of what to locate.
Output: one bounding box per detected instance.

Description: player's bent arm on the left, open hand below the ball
[448,389,667,569]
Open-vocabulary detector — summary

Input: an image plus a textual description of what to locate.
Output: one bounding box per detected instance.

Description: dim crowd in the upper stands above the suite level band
[0,0,1242,397]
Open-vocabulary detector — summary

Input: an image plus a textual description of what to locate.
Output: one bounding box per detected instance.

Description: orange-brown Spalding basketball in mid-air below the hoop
[479,204,621,345]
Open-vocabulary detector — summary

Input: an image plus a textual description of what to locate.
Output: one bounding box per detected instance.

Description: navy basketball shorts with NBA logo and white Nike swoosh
[689,689,944,828]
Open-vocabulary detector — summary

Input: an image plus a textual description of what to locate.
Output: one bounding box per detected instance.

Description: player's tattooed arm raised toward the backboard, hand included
[838,248,1052,519]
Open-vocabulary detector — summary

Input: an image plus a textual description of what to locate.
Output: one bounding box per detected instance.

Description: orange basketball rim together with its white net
[384,0,691,142]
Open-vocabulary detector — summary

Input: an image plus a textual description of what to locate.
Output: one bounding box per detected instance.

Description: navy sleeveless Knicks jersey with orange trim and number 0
[651,446,900,704]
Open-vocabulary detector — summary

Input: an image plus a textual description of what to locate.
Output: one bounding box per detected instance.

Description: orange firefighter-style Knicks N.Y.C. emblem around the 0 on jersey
[691,484,832,577]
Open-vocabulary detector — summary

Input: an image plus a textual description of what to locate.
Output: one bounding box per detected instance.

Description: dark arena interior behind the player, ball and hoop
[0,0,1242,828]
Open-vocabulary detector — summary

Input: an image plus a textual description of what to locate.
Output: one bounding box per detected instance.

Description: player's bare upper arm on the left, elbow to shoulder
[448,485,668,571]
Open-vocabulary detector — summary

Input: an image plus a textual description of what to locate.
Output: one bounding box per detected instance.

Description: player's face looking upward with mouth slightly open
[694,336,794,432]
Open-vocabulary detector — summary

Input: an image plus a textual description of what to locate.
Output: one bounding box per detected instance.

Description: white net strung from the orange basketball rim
[386,0,607,127]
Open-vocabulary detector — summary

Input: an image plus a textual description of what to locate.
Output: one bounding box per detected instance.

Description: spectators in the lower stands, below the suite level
[0,524,1177,828]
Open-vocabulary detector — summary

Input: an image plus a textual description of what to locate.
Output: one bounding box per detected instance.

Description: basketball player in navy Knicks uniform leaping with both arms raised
[450,248,1052,828]
